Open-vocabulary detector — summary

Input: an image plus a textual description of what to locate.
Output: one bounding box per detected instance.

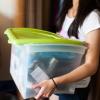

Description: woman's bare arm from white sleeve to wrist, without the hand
[54,29,100,84]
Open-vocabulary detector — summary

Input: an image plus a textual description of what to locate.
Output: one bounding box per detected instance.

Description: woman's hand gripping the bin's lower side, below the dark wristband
[32,79,55,99]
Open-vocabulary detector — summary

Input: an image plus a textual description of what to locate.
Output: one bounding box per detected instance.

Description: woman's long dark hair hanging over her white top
[56,0,98,38]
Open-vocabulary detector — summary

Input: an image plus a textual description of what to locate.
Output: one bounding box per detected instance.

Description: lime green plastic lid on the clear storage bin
[4,28,84,45]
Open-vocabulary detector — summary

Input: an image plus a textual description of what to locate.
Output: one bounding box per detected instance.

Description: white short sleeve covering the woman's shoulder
[80,9,100,33]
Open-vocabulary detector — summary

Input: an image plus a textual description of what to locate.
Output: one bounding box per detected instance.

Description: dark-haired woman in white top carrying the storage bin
[33,0,100,100]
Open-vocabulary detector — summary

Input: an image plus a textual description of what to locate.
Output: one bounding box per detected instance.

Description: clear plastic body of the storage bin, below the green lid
[10,44,88,99]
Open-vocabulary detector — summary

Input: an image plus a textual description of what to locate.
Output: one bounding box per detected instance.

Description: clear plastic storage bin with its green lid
[5,28,89,99]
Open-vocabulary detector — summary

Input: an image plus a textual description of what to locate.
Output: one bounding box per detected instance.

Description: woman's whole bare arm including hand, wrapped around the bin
[33,29,100,99]
